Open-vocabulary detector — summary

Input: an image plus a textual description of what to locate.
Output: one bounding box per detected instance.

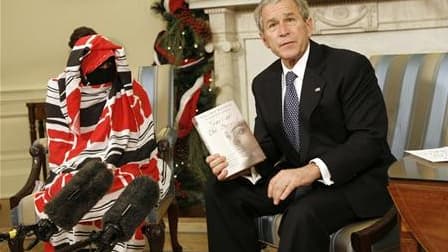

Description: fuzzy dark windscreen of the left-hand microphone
[45,159,114,230]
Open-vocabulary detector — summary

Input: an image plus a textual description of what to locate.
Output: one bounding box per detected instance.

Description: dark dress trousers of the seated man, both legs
[205,178,356,252]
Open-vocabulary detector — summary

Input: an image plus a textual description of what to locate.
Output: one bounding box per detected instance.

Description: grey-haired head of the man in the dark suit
[260,0,313,68]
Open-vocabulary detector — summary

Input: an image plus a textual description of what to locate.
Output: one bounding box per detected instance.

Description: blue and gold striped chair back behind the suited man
[372,53,448,158]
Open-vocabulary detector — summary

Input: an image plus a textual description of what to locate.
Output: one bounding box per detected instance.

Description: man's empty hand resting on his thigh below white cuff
[268,163,321,205]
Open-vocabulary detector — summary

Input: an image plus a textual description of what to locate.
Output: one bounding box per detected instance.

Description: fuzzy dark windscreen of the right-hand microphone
[103,176,159,242]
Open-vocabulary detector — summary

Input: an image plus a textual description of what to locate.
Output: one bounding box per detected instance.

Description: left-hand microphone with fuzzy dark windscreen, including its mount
[0,159,113,250]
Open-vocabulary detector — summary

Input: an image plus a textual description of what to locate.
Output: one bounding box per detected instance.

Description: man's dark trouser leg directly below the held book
[205,178,286,252]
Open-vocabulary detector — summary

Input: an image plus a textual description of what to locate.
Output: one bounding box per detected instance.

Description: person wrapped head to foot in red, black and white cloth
[35,27,169,251]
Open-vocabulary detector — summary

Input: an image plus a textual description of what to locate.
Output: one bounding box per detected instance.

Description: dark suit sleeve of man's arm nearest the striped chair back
[320,56,389,184]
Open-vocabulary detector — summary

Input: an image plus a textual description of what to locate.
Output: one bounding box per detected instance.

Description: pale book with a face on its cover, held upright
[193,101,266,179]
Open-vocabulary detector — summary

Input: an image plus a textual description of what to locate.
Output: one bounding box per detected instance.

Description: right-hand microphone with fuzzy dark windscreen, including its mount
[57,176,160,252]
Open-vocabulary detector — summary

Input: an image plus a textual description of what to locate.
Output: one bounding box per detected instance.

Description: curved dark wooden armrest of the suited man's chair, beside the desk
[351,206,397,251]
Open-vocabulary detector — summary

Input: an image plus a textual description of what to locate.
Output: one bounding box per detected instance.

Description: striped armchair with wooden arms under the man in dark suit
[256,52,448,251]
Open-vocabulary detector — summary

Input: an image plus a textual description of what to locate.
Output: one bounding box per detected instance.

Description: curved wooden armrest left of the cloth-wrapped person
[9,139,46,209]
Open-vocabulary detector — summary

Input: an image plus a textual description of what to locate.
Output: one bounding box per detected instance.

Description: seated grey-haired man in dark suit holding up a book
[206,0,395,252]
